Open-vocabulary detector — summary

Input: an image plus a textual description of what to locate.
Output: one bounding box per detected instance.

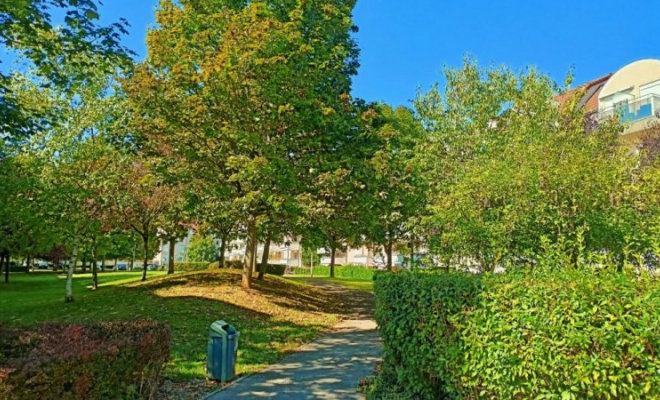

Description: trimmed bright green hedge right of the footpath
[369,268,660,400]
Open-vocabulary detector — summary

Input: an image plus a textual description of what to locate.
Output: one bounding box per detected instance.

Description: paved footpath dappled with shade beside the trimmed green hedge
[208,282,382,400]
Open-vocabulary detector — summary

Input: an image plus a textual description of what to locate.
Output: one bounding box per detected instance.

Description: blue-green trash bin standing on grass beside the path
[206,321,240,383]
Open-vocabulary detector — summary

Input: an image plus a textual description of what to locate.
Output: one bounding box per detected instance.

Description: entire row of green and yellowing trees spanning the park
[0,0,660,300]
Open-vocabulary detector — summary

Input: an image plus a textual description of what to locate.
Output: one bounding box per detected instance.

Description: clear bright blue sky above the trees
[101,0,660,105]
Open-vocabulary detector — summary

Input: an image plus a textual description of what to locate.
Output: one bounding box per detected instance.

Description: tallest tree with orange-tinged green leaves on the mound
[125,0,357,288]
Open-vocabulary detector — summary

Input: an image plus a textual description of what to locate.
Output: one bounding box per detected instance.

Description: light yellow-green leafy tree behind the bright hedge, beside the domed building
[416,60,650,270]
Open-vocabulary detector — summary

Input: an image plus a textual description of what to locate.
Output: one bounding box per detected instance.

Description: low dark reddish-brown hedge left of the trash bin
[0,321,170,400]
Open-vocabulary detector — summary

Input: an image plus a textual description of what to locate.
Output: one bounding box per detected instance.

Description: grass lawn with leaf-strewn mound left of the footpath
[0,270,338,382]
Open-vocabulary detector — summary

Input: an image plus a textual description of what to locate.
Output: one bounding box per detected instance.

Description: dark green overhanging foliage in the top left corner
[0,0,131,141]
